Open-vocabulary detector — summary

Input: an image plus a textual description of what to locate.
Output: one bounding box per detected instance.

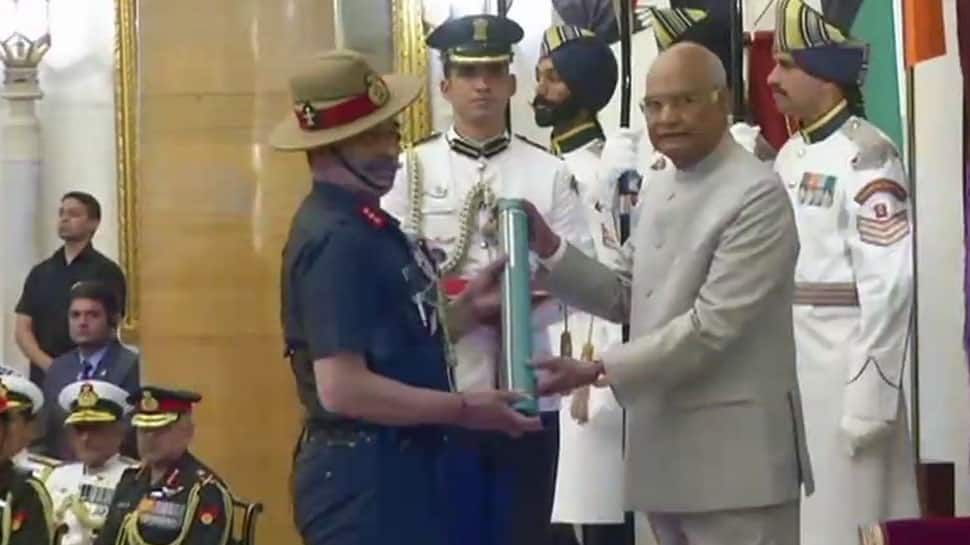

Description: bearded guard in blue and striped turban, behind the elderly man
[533,26,627,545]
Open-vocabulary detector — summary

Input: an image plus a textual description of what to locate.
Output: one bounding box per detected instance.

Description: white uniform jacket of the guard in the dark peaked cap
[381,127,593,411]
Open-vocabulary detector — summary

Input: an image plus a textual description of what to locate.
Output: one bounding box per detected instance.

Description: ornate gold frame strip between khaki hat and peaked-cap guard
[391,0,431,145]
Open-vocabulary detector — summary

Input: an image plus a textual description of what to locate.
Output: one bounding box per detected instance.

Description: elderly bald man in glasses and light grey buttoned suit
[530,43,812,545]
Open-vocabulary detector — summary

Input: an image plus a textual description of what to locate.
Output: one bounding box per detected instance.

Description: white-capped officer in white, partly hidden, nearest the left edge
[0,366,59,481]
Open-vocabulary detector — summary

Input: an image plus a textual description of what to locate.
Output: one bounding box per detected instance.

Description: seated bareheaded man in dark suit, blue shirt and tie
[43,282,141,461]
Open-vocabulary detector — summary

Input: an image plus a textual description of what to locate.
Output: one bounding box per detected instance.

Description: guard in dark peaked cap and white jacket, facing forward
[383,15,592,545]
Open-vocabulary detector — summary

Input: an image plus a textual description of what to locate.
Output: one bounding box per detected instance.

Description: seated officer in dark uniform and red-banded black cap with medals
[95,386,232,545]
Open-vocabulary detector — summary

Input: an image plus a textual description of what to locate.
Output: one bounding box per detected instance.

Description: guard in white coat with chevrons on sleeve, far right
[768,0,919,545]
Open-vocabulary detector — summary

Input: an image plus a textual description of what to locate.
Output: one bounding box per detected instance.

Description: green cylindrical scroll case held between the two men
[498,199,539,414]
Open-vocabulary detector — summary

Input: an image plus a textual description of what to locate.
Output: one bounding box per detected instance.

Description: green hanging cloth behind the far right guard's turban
[851,0,903,150]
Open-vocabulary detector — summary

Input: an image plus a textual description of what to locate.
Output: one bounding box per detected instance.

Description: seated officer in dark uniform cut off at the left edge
[0,376,53,545]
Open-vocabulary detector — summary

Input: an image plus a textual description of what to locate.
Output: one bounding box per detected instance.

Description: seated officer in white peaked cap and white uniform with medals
[44,380,137,545]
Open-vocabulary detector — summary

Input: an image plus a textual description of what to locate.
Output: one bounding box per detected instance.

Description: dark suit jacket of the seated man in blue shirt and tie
[41,340,141,460]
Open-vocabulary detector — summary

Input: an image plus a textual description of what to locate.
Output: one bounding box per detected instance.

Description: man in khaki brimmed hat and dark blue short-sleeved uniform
[270,51,540,545]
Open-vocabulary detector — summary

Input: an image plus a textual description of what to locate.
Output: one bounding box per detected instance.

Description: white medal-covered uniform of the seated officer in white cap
[45,455,137,545]
